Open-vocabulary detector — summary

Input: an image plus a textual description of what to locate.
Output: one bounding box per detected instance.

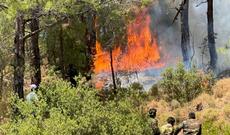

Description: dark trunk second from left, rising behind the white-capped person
[30,7,41,86]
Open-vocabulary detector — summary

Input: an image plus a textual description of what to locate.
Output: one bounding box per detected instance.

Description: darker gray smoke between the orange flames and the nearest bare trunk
[150,0,182,65]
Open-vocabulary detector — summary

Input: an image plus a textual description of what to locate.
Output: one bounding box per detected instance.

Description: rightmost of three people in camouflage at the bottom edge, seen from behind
[175,113,202,135]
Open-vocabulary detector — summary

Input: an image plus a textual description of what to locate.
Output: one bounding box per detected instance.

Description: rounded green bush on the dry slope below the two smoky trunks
[160,63,214,103]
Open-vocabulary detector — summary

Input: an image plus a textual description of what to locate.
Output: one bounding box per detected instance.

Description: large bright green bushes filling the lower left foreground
[0,79,150,135]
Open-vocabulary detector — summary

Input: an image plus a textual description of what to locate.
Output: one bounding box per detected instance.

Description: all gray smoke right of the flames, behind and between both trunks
[150,0,230,72]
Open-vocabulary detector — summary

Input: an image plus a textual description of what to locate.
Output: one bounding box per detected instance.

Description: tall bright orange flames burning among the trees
[94,10,164,74]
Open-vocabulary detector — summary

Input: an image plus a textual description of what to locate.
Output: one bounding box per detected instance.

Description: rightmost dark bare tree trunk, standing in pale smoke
[207,0,217,70]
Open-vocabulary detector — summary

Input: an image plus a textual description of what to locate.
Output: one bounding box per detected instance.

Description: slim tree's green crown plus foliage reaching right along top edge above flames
[97,0,150,50]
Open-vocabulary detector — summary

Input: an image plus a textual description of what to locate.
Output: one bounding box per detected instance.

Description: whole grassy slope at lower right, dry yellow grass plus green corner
[147,78,230,135]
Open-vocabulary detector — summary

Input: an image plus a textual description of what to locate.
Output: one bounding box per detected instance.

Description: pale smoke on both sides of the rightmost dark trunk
[190,0,230,73]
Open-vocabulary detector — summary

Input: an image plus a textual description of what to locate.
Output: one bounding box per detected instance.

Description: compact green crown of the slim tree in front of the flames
[97,1,130,49]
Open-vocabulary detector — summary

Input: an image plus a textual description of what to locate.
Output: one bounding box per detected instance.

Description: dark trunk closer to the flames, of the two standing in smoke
[181,0,191,69]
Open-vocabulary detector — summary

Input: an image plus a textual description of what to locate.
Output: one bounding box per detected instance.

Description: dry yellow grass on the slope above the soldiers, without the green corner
[147,78,230,124]
